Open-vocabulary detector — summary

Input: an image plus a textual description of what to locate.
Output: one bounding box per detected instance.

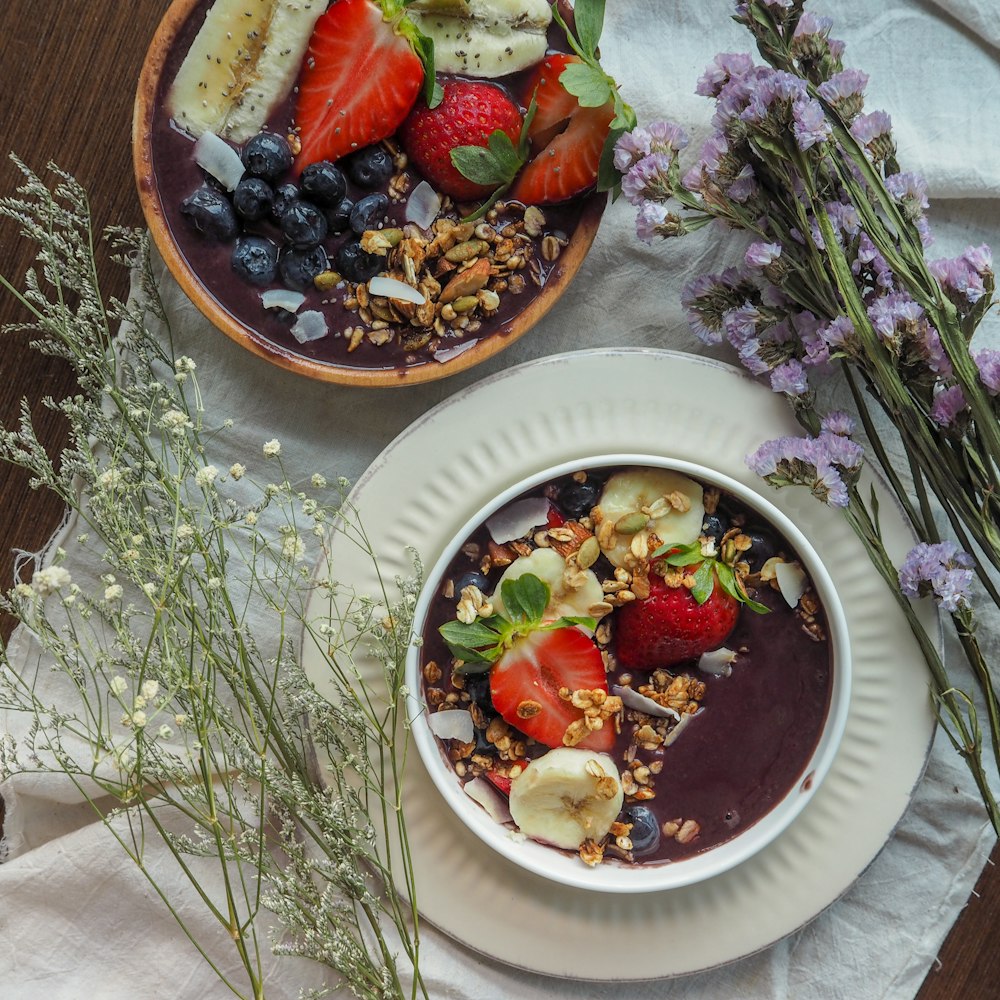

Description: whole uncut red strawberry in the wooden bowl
[400,80,523,201]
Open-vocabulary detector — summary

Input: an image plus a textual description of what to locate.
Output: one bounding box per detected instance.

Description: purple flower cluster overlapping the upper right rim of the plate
[747,428,864,507]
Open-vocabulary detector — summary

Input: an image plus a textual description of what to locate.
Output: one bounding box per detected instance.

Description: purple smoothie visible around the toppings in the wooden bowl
[149,0,606,371]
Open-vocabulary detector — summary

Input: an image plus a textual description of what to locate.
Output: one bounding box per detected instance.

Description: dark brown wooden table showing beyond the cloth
[0,0,1000,1000]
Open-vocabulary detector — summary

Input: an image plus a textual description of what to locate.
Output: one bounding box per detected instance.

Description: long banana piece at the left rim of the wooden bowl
[166,0,326,142]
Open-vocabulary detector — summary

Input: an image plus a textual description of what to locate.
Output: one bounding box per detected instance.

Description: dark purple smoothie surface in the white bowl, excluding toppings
[421,469,833,865]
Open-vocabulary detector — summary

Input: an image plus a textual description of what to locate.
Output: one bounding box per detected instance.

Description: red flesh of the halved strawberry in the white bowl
[490,627,615,751]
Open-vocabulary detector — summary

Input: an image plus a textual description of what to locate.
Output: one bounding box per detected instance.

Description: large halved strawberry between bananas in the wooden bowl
[295,0,424,170]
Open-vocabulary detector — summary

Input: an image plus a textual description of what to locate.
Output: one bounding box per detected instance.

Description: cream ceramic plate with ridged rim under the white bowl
[303,350,936,981]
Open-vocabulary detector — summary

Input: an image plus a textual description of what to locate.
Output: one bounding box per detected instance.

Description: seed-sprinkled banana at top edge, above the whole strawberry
[407,0,552,79]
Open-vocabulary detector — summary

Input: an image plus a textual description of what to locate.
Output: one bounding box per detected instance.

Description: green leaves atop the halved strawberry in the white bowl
[438,573,597,674]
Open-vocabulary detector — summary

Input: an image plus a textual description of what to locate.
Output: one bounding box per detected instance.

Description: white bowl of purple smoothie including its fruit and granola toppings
[406,455,850,892]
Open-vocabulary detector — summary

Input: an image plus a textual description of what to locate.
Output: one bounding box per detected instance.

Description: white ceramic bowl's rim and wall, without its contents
[406,454,851,893]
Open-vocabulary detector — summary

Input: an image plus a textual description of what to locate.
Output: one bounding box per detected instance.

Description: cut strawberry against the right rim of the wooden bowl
[510,54,615,205]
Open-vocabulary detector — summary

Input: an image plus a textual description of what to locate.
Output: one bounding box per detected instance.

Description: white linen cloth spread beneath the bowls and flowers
[0,0,1000,1000]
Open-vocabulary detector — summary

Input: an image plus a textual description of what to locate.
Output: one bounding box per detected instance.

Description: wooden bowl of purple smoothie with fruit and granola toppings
[133,0,608,386]
